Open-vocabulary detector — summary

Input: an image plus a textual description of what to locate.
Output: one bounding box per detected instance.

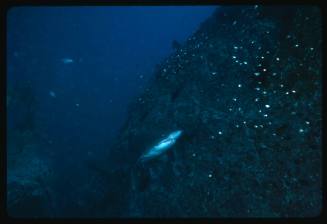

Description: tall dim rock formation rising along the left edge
[6,82,55,218]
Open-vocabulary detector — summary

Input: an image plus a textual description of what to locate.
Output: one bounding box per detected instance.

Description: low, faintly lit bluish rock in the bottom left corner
[7,145,54,218]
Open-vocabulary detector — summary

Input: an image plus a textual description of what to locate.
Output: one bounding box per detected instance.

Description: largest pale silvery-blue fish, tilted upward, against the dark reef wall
[139,130,182,162]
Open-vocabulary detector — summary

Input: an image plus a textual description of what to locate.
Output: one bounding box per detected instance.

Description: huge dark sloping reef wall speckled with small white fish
[90,6,322,217]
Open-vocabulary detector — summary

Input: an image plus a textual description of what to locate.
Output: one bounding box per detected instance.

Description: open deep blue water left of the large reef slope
[7,6,216,216]
